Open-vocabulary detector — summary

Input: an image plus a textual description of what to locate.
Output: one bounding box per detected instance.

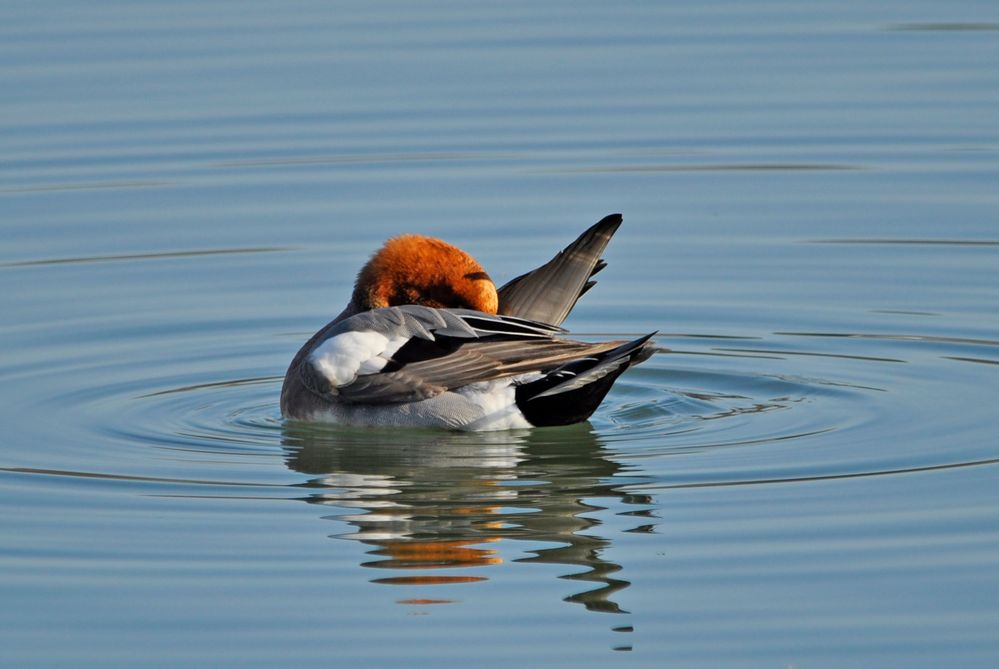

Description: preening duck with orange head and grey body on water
[280,214,657,431]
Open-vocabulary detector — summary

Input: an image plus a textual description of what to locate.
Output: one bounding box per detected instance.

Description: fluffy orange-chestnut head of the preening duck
[352,235,499,314]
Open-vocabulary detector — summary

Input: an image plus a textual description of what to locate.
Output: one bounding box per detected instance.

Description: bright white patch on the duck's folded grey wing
[309,330,409,388]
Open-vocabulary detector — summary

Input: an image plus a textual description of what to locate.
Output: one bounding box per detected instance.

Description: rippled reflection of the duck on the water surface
[283,424,650,612]
